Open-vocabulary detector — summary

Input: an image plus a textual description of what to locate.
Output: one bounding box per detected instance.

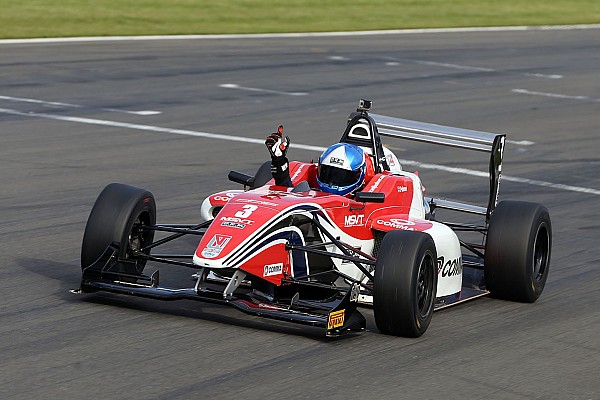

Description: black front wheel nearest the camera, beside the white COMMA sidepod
[373,231,437,337]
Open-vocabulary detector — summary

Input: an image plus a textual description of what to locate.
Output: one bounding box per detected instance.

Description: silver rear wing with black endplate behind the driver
[370,113,506,222]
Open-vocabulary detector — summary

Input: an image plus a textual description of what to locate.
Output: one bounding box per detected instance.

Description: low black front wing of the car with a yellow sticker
[75,243,366,336]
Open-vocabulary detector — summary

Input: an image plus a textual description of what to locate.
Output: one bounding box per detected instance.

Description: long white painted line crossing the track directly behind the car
[0,108,600,196]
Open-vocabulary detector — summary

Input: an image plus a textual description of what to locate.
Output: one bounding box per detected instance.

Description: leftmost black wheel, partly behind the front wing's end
[81,183,156,275]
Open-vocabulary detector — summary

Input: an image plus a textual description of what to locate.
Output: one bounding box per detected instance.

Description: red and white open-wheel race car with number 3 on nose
[76,100,552,337]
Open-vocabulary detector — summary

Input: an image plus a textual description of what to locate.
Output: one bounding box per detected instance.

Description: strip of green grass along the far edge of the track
[0,0,600,38]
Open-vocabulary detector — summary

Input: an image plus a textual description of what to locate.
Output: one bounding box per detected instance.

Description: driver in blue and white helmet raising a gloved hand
[265,125,367,196]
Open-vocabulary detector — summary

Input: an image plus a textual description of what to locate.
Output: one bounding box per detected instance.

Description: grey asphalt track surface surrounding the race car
[0,29,600,400]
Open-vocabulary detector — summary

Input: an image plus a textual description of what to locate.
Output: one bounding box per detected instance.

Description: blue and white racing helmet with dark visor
[317,143,366,196]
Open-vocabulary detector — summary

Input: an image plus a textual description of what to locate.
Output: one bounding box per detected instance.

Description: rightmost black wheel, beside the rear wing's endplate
[484,201,552,303]
